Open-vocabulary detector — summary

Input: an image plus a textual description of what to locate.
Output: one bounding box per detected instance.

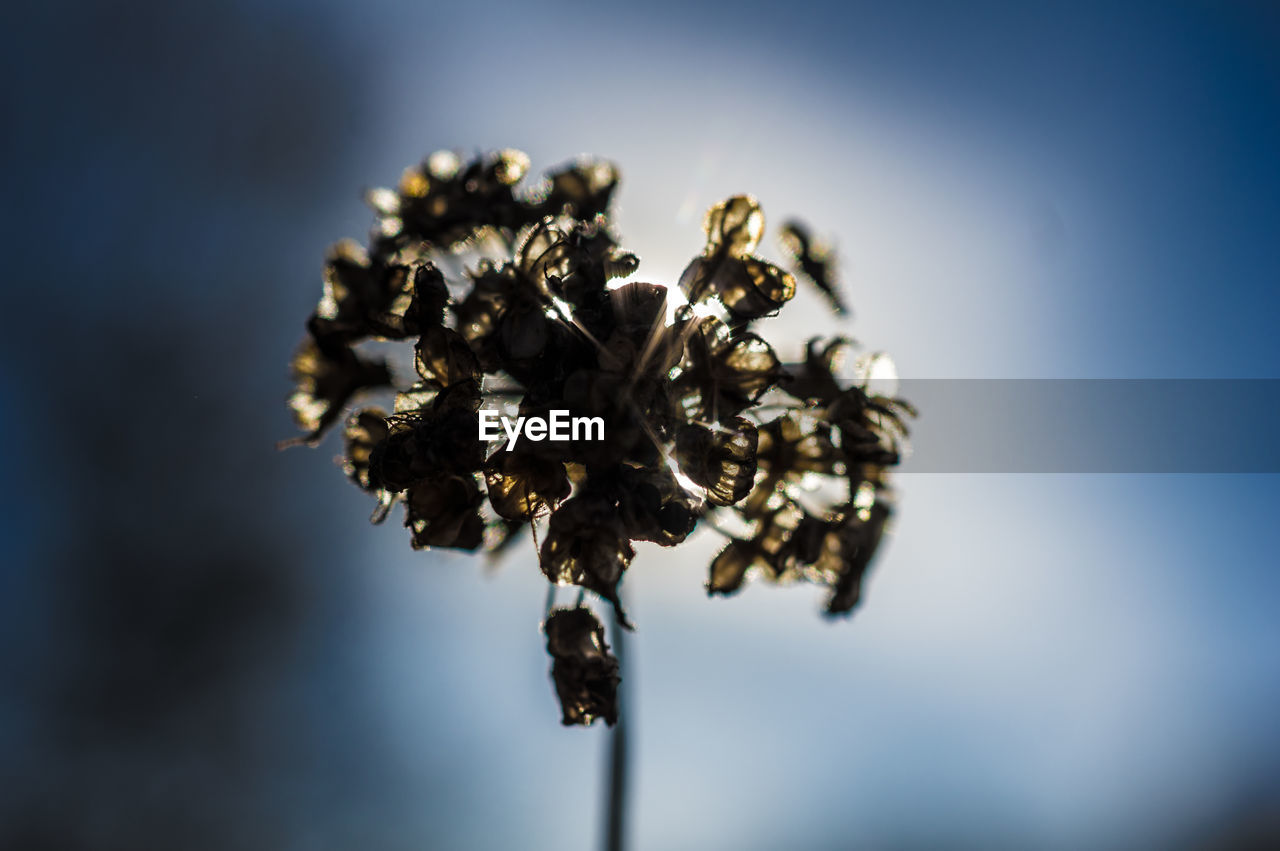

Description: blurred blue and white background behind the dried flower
[0,0,1280,851]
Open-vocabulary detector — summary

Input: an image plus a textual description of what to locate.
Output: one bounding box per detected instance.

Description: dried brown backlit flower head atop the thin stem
[289,150,913,724]
